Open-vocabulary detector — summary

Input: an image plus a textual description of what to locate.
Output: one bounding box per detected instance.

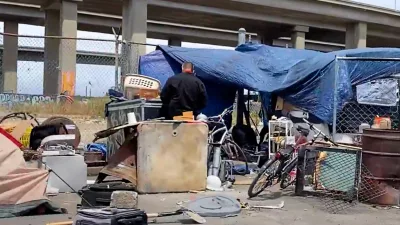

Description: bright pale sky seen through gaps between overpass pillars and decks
[0,22,233,97]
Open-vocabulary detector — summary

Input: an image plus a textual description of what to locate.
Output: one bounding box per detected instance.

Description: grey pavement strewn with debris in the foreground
[0,185,400,225]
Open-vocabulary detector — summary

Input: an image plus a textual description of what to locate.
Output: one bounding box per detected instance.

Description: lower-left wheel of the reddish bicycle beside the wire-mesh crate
[247,157,282,198]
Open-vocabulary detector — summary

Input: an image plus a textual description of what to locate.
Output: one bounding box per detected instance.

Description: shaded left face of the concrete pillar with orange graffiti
[43,10,61,95]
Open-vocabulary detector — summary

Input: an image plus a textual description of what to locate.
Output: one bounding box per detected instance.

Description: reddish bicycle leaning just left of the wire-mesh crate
[247,112,338,198]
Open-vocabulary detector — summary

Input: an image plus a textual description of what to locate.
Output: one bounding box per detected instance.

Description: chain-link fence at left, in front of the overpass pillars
[0,34,151,143]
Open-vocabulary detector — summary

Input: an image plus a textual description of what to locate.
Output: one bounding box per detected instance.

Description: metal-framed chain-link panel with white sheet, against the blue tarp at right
[333,58,400,134]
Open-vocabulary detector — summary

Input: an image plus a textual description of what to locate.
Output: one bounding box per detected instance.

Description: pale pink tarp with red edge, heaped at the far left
[0,128,62,218]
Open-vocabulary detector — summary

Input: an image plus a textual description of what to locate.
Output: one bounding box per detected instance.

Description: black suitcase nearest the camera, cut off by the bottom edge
[73,208,147,225]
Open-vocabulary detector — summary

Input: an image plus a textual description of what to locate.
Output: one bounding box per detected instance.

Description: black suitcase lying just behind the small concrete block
[79,181,136,208]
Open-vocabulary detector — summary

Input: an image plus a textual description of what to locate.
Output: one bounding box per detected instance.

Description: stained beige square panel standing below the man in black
[137,122,208,193]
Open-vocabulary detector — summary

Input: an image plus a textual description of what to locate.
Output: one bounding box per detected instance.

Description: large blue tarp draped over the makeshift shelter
[139,44,400,122]
